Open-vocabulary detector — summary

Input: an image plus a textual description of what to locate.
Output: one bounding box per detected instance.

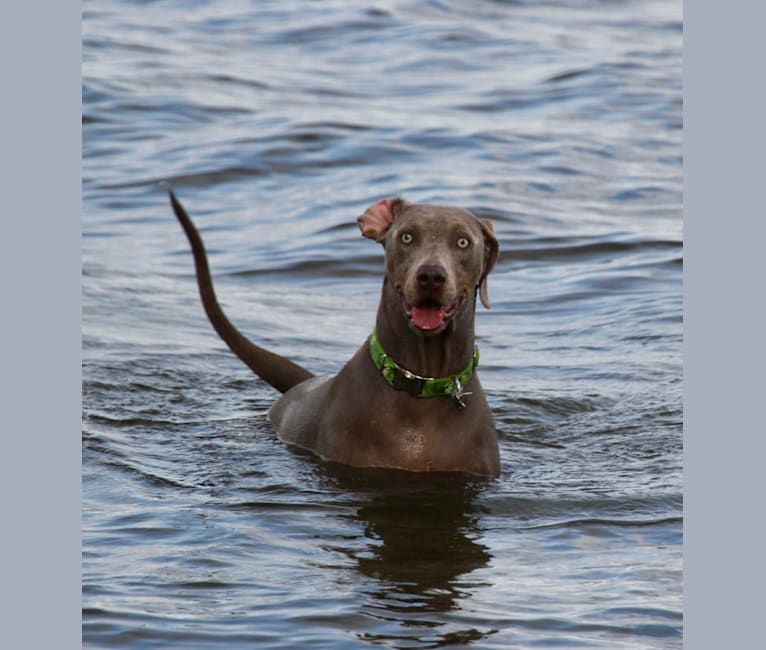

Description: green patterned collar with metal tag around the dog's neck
[370,330,479,408]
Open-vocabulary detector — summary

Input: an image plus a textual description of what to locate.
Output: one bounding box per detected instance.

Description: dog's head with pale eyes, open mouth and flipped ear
[357,199,498,334]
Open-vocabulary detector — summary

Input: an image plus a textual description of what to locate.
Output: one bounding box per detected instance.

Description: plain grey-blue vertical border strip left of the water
[0,2,81,648]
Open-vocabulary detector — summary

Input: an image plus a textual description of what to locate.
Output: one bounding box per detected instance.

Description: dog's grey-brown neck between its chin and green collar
[375,279,476,377]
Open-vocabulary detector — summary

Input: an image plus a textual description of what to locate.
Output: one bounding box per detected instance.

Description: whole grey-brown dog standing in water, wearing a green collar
[170,191,500,476]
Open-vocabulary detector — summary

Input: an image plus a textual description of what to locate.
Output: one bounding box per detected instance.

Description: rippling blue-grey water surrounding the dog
[82,0,683,650]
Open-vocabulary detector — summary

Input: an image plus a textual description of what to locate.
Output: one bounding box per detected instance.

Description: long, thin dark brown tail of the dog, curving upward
[168,188,314,393]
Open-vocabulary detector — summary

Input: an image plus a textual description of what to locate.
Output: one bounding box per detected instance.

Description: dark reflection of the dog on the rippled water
[322,460,491,625]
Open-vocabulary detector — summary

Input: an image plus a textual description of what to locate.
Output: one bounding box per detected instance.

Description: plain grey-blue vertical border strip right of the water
[684,1,766,650]
